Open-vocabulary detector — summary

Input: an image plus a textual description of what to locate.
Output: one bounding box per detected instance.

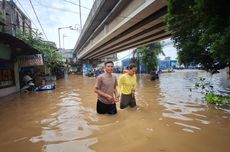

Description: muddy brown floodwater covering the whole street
[0,71,230,152]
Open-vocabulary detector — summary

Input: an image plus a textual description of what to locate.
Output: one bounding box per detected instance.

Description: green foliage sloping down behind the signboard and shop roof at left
[16,31,63,69]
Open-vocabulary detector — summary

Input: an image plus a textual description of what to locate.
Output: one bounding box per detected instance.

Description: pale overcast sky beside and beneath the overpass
[14,0,176,59]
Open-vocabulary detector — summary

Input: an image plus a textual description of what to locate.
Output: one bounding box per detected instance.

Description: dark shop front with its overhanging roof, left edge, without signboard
[0,32,39,97]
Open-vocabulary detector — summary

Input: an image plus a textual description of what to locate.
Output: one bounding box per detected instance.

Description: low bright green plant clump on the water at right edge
[205,93,230,104]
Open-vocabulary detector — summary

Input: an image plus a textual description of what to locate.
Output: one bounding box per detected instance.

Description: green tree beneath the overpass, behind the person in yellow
[137,42,164,72]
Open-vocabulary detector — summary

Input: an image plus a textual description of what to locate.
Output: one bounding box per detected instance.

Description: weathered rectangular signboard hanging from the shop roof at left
[18,54,44,67]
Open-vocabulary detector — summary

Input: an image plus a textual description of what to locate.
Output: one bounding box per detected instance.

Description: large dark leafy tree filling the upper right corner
[166,0,230,72]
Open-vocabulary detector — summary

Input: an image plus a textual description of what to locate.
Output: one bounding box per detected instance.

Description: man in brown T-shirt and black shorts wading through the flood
[95,61,119,115]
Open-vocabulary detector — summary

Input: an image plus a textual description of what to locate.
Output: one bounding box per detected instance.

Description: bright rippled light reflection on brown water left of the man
[30,91,97,152]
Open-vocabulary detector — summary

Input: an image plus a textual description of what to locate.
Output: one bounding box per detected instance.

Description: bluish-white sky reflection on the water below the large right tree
[160,71,229,124]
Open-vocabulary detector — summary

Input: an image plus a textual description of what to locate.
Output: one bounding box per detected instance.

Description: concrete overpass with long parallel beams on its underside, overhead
[74,0,170,60]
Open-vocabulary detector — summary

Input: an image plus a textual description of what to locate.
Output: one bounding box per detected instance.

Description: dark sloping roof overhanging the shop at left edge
[0,32,40,56]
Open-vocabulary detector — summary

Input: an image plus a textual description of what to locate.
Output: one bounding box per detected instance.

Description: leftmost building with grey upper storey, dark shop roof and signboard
[0,0,43,97]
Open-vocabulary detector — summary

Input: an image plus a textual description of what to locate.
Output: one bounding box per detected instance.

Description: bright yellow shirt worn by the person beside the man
[117,73,137,94]
